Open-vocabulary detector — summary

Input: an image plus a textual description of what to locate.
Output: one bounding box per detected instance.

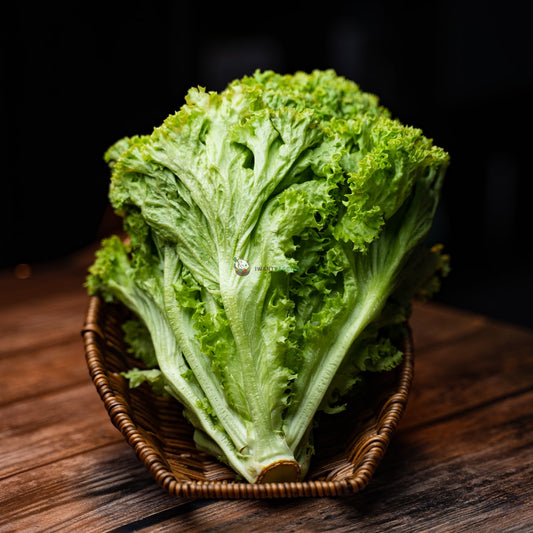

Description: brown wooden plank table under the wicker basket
[0,246,533,533]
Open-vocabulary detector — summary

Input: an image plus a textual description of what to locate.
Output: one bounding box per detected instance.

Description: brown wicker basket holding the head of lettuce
[82,297,414,498]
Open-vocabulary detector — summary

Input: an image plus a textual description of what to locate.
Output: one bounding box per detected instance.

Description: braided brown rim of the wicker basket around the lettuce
[81,296,414,499]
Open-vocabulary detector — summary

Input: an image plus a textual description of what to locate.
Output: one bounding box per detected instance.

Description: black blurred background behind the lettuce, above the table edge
[0,0,533,327]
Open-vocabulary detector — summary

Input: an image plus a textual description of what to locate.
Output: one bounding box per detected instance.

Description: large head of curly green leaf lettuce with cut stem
[87,71,448,482]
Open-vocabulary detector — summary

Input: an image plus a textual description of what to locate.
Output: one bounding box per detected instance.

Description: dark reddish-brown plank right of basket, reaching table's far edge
[401,322,533,427]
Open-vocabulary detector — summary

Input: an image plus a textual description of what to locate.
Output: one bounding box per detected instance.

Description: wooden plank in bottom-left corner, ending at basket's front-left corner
[0,443,181,533]
